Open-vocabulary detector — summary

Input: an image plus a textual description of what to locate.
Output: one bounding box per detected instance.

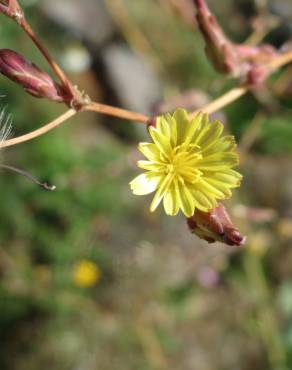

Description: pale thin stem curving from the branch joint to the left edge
[0,109,77,148]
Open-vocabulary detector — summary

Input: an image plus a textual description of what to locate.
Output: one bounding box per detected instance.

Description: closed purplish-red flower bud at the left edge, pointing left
[0,49,68,102]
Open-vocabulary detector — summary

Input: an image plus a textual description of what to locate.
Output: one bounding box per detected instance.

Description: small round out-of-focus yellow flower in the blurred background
[73,260,101,288]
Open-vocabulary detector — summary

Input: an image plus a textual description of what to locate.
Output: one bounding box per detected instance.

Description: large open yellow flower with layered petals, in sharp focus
[130,109,242,217]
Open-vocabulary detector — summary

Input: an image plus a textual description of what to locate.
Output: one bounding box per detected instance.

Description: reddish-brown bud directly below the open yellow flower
[187,204,245,246]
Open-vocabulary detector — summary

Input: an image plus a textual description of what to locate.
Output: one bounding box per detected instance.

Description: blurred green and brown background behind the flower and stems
[0,0,292,370]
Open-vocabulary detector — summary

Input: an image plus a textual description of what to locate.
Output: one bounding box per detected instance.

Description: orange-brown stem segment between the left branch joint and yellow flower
[83,103,150,123]
